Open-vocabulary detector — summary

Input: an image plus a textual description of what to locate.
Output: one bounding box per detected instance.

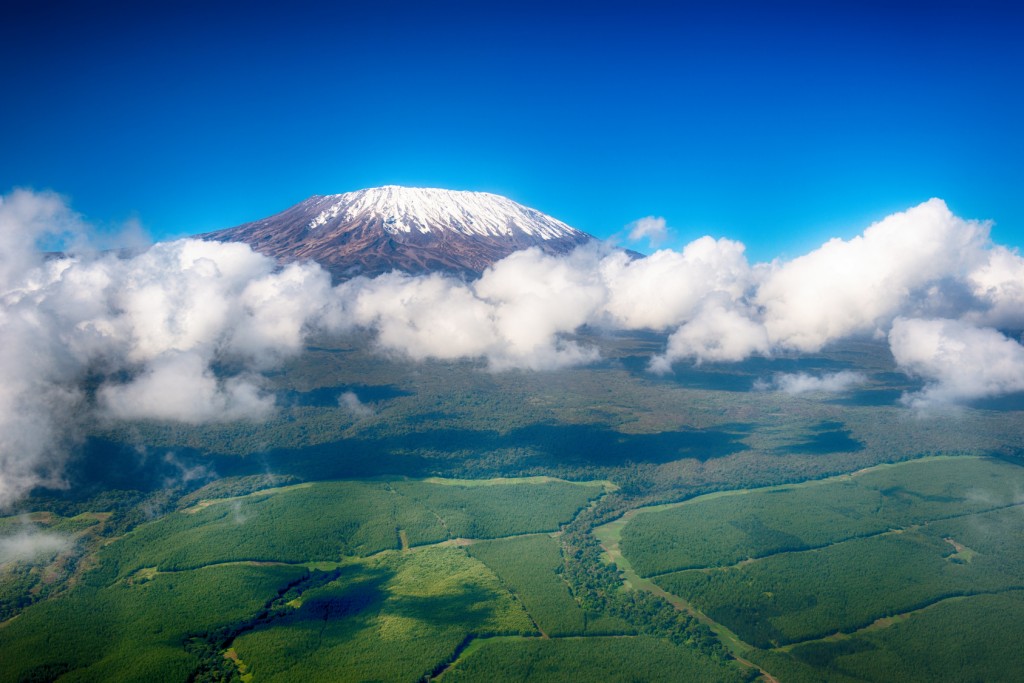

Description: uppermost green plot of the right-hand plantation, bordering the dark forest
[622,458,1022,577]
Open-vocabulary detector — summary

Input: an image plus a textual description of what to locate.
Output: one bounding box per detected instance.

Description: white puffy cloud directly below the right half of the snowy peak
[336,249,604,370]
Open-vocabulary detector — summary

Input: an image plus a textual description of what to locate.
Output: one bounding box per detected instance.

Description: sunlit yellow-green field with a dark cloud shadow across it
[233,548,537,681]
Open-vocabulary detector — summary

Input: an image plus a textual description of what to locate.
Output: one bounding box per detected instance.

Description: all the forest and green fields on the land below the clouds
[6,333,1024,683]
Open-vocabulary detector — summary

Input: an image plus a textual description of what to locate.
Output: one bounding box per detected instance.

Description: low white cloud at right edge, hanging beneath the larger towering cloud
[889,318,1024,409]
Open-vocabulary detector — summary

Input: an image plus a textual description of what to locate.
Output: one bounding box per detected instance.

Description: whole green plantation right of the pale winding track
[598,458,1024,681]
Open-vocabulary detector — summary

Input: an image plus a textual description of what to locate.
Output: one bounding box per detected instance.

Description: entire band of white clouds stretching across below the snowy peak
[0,191,1024,506]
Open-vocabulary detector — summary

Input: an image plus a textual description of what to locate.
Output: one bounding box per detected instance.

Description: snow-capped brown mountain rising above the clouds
[200,185,596,280]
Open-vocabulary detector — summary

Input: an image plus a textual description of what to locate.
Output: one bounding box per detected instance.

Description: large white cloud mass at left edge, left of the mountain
[0,190,340,507]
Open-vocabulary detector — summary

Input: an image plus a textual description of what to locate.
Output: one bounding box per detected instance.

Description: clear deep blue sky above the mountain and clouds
[0,0,1024,259]
